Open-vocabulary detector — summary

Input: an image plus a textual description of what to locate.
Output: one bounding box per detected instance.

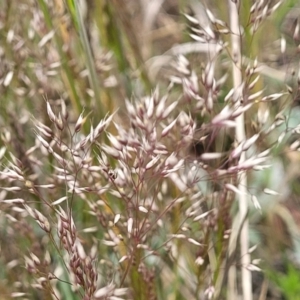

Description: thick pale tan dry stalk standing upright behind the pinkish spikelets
[228,0,252,300]
